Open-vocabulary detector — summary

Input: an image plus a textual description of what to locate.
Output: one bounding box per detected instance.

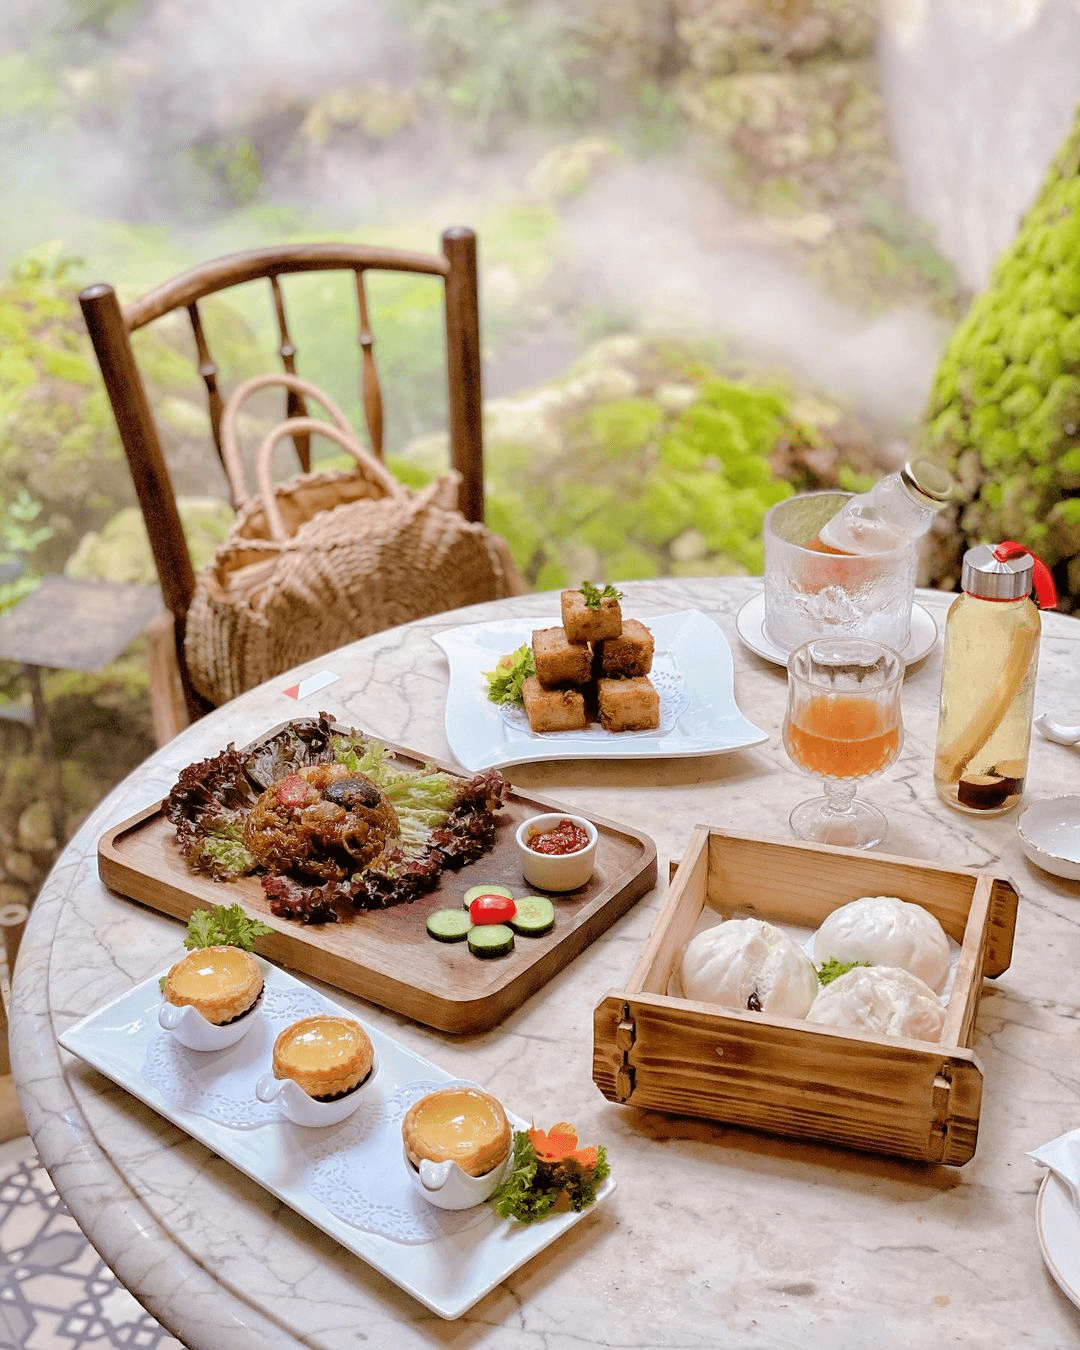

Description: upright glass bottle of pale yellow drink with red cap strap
[934,540,1057,815]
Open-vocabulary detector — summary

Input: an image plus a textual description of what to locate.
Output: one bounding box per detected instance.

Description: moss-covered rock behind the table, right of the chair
[408,336,837,590]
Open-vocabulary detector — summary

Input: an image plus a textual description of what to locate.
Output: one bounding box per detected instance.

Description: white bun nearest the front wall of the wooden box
[806,965,945,1041]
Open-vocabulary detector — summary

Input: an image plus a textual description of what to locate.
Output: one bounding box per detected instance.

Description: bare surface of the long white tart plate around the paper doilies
[59,961,614,1318]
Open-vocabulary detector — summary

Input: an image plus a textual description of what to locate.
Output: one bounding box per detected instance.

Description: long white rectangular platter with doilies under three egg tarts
[59,960,614,1318]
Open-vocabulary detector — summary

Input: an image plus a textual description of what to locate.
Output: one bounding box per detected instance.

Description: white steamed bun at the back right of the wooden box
[814,895,949,994]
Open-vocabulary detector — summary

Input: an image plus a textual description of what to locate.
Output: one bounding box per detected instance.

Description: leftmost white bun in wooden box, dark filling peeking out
[680,919,818,1018]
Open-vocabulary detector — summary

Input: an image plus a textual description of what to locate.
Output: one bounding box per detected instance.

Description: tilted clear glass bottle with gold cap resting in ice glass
[807,459,953,554]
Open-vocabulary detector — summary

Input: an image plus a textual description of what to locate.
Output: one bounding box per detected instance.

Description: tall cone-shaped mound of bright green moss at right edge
[926,108,1080,609]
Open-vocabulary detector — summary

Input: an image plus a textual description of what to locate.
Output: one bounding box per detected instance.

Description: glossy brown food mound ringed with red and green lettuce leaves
[163,713,505,923]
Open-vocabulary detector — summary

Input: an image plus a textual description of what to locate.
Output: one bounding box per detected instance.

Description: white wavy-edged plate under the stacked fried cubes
[435,609,768,774]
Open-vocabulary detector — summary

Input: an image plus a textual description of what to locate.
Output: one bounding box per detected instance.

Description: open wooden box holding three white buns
[593,826,1018,1166]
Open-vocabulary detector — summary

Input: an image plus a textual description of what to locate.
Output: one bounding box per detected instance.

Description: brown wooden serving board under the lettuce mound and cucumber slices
[97,745,656,1033]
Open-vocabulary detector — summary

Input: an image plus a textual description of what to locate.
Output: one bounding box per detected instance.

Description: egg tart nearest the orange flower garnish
[401,1087,510,1177]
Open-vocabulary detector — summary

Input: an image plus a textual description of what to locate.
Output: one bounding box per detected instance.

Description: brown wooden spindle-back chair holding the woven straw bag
[80,228,483,744]
